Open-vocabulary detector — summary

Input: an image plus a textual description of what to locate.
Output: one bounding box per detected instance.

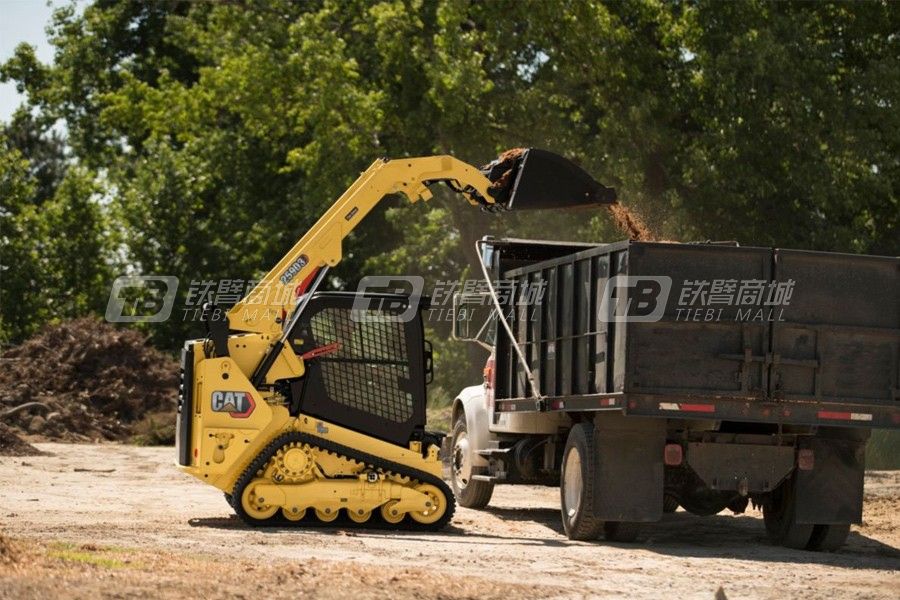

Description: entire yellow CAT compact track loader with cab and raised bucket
[176,149,615,529]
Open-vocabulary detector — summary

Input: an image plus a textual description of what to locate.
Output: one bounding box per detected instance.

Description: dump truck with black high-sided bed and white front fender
[444,238,900,551]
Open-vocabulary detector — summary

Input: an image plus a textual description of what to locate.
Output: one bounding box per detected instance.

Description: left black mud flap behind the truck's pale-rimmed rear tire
[594,415,666,522]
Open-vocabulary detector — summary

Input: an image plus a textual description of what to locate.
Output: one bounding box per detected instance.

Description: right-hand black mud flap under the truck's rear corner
[795,437,866,525]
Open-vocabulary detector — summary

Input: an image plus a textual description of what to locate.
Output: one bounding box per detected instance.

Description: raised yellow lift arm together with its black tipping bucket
[207,148,615,389]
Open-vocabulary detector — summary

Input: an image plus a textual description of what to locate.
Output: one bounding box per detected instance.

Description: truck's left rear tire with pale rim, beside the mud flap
[559,423,603,540]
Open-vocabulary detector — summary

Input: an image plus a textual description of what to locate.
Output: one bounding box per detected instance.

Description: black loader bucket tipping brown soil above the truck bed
[481,148,616,210]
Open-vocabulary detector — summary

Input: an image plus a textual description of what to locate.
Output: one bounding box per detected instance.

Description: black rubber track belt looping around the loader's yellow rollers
[231,431,456,531]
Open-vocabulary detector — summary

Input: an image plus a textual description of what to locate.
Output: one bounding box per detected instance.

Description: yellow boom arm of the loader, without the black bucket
[228,156,494,334]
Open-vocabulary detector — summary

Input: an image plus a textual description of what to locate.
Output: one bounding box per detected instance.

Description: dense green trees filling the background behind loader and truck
[0,0,900,394]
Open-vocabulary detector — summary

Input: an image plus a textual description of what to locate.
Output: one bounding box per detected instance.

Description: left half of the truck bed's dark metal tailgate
[625,244,772,397]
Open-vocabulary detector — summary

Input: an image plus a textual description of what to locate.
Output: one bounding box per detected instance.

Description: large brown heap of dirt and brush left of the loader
[0,318,178,441]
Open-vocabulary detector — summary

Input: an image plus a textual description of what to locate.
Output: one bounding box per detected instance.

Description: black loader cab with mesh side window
[286,292,432,446]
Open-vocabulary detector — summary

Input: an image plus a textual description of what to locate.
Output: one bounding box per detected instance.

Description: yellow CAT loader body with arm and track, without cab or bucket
[179,156,500,525]
